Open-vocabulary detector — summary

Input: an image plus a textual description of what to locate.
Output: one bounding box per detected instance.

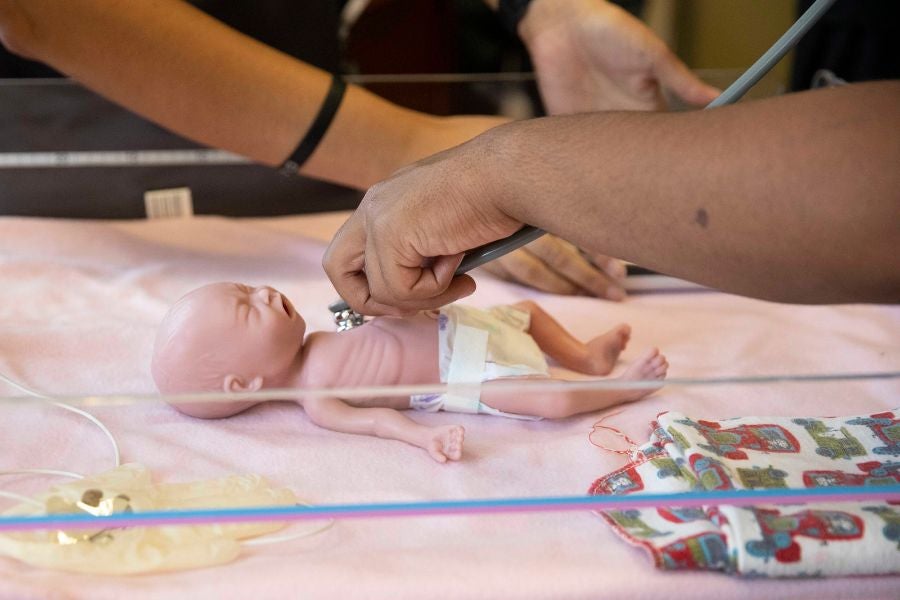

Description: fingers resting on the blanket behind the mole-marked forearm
[482,234,625,300]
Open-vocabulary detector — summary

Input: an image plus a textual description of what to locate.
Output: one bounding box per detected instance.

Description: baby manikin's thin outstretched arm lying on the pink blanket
[303,398,465,462]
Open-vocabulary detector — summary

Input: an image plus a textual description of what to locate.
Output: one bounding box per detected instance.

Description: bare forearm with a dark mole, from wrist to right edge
[492,82,900,302]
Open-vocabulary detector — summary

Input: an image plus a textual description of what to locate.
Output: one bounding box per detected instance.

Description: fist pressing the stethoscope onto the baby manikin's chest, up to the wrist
[322,134,522,315]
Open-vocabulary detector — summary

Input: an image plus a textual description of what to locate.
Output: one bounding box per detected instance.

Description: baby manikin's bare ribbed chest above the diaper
[300,311,440,408]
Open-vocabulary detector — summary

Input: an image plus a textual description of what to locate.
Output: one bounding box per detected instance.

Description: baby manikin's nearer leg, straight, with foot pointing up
[481,348,669,419]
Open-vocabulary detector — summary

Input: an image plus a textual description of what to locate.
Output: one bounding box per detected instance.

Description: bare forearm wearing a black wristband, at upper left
[0,0,436,187]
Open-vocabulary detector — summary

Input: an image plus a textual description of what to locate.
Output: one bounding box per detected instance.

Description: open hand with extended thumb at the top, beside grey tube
[519,0,719,114]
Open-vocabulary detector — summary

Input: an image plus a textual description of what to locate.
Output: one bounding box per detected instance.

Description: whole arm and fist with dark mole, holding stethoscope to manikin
[324,82,900,313]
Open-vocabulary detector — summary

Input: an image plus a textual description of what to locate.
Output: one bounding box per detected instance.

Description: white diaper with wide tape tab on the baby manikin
[410,304,549,420]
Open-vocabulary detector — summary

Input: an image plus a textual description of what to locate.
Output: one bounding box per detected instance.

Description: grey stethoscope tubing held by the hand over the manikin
[329,0,835,312]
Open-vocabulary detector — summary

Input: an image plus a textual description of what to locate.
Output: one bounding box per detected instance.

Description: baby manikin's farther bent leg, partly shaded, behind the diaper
[513,300,631,375]
